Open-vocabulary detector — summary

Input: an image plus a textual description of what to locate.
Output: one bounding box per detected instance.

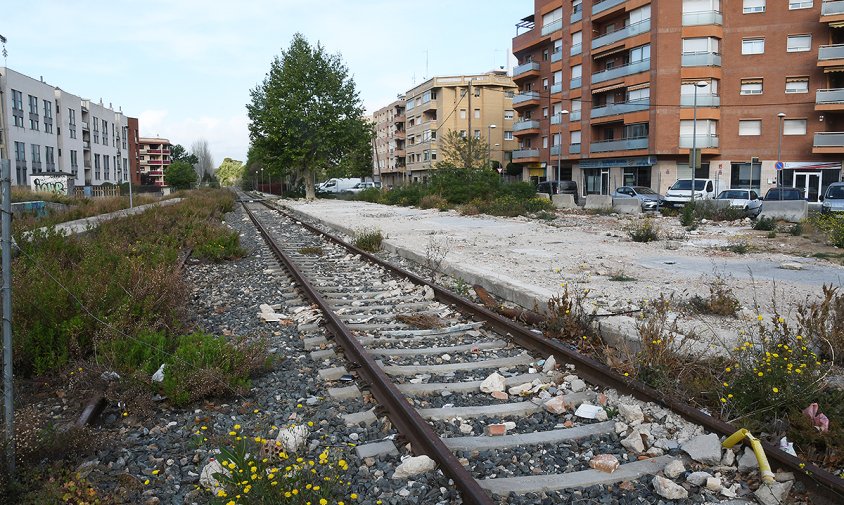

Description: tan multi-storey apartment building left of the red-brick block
[404,71,517,182]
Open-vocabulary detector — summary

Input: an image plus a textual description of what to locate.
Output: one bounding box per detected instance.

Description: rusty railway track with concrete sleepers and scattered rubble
[234,191,844,504]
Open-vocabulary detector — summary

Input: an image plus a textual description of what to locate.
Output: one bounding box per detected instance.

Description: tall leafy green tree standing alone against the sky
[246,33,365,199]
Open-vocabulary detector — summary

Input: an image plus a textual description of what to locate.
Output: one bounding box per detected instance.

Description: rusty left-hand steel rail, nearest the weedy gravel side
[243,203,495,505]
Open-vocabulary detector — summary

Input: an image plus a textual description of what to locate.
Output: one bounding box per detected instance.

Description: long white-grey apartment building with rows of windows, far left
[0,67,128,186]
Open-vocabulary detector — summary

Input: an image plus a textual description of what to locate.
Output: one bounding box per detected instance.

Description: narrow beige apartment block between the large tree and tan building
[372,98,407,187]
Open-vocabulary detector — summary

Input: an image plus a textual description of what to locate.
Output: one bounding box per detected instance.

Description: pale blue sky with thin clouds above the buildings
[0,0,533,165]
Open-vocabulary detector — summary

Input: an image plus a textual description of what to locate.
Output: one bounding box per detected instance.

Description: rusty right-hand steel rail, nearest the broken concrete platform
[260,200,844,505]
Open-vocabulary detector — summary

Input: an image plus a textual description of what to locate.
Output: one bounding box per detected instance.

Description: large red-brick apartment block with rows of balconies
[513,0,844,201]
